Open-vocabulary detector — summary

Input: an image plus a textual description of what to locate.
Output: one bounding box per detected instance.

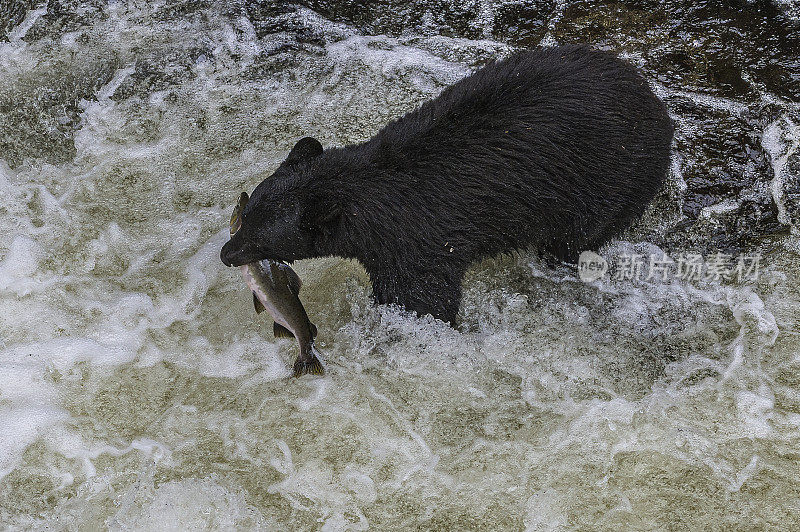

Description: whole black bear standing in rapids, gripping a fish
[220,45,673,324]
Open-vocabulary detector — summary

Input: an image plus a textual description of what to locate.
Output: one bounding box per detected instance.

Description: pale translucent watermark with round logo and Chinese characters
[578,251,761,283]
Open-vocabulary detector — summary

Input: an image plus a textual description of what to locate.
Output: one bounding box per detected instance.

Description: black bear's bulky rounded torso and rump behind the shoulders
[367,45,673,258]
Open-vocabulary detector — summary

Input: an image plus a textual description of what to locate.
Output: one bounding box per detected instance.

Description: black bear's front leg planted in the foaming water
[372,268,464,326]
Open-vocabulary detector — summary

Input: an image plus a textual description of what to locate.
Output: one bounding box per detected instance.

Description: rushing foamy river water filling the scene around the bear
[0,0,800,530]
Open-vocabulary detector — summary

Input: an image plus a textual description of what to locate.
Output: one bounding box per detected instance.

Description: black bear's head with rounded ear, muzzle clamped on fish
[220,137,340,266]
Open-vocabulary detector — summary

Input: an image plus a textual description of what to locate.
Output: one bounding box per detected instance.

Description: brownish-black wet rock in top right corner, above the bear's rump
[553,0,800,100]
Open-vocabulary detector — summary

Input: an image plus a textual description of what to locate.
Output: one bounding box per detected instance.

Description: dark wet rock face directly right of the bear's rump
[656,97,787,252]
